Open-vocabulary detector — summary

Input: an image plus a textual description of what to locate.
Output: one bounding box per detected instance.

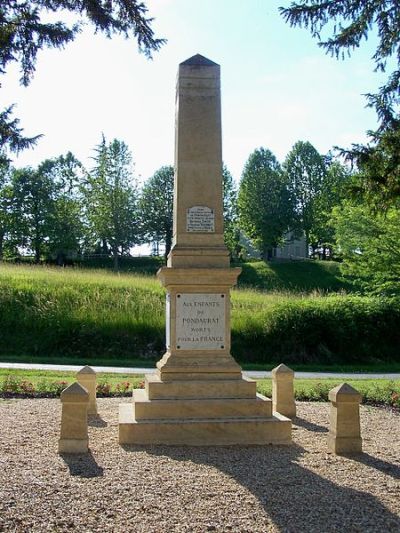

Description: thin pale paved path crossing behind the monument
[0,363,400,380]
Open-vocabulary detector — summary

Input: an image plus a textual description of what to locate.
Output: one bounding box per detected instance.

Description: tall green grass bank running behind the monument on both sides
[0,262,400,369]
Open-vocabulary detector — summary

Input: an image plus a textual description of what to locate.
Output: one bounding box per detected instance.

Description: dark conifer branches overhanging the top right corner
[280,0,400,201]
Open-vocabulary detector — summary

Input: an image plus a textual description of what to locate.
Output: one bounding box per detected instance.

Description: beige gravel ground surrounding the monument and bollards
[0,399,400,533]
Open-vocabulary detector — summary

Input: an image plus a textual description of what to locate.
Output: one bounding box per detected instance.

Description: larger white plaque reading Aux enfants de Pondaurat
[176,293,226,350]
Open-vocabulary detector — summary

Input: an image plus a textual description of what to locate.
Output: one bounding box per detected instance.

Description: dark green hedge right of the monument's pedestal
[232,296,400,364]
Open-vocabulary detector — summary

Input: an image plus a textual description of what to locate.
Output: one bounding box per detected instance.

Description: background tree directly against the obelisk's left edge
[139,166,174,257]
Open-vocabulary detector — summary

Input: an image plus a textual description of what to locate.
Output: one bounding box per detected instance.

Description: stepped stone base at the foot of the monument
[119,375,292,445]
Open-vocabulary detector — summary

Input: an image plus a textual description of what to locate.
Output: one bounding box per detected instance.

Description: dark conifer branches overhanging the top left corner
[0,0,165,155]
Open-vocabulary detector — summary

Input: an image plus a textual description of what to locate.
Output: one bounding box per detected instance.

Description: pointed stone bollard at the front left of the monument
[58,382,89,453]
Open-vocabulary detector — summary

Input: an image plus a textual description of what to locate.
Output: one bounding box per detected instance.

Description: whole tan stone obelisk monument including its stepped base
[119,55,291,445]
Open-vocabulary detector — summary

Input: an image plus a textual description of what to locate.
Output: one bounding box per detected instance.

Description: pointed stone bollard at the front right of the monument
[328,383,362,455]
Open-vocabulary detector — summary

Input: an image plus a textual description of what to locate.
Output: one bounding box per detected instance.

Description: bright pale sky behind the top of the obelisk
[0,0,384,182]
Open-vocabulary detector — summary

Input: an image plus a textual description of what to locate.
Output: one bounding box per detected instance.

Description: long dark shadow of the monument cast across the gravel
[140,445,400,533]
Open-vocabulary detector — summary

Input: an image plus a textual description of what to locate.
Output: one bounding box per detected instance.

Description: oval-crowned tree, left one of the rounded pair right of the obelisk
[238,148,293,259]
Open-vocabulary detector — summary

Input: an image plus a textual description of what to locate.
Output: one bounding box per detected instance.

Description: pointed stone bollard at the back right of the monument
[272,364,296,418]
